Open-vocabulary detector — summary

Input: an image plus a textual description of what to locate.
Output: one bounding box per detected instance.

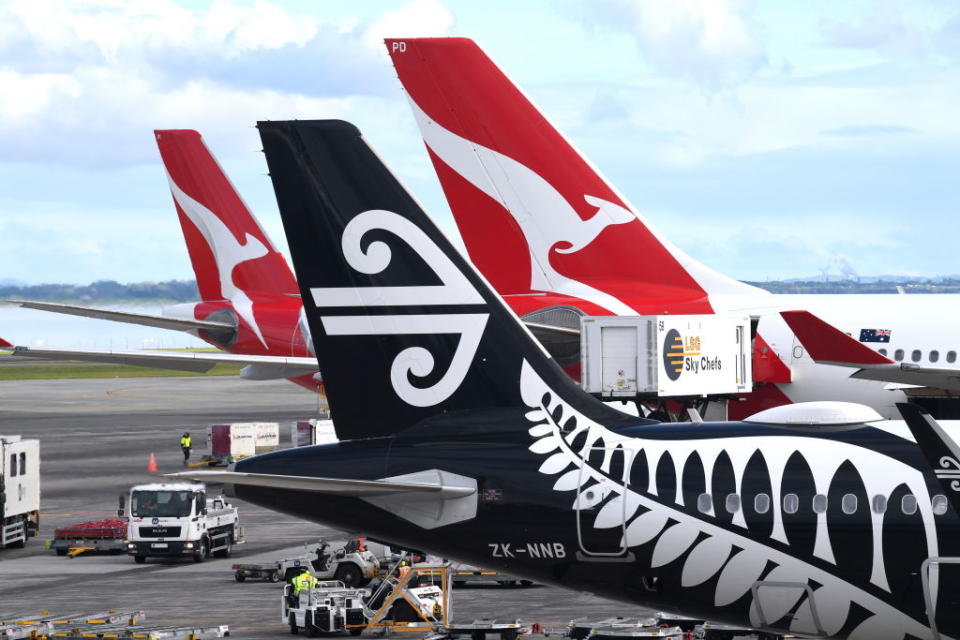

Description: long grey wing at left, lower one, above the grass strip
[0,341,319,380]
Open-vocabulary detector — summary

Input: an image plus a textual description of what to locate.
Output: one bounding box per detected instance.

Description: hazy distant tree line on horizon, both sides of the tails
[0,278,960,304]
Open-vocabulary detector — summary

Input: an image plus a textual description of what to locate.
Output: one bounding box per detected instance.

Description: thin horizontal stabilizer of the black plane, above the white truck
[166,471,477,498]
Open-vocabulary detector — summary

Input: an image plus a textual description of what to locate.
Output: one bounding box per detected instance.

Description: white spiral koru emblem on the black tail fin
[310,209,489,407]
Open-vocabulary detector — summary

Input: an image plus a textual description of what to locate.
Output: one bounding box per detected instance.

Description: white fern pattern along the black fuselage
[521,362,946,640]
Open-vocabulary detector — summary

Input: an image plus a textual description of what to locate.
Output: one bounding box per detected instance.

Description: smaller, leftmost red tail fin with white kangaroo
[154,129,298,303]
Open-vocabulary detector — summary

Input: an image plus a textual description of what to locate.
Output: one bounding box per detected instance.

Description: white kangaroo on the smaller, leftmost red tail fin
[167,176,270,347]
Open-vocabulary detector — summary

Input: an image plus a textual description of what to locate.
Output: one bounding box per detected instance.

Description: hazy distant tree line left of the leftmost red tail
[0,280,200,303]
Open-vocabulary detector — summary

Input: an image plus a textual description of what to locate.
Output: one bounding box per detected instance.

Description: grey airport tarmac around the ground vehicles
[0,377,648,638]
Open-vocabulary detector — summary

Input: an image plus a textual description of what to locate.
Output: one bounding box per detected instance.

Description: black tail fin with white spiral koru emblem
[258,120,622,439]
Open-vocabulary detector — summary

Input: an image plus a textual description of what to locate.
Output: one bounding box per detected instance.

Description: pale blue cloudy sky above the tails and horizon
[0,0,960,283]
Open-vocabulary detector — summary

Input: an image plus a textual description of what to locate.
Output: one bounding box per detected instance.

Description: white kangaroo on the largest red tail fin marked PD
[410,100,636,315]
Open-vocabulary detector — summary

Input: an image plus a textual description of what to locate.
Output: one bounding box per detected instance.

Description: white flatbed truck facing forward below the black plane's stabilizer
[117,483,243,563]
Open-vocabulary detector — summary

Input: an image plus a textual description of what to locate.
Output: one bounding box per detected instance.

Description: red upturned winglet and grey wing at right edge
[780,311,960,393]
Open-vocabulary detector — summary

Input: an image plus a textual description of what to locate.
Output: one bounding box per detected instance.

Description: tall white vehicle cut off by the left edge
[0,435,40,549]
